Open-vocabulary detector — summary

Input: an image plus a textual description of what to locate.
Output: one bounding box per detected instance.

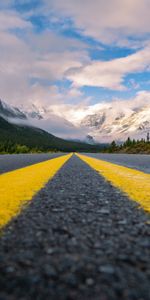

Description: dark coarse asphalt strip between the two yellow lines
[0,155,150,300]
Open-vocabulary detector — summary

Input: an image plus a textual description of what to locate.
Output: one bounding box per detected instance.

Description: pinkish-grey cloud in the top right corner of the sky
[44,0,150,45]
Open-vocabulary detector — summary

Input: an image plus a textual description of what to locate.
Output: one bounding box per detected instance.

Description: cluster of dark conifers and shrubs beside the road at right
[105,134,150,154]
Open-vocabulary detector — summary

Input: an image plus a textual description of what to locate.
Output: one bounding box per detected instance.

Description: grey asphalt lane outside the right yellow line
[86,153,150,173]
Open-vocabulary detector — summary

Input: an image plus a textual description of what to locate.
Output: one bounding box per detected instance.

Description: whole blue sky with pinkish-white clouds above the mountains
[0,0,150,137]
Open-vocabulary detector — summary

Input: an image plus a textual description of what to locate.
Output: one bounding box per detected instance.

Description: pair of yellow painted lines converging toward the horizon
[0,154,150,228]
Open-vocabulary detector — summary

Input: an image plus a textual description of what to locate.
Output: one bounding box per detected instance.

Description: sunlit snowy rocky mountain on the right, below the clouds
[80,104,150,141]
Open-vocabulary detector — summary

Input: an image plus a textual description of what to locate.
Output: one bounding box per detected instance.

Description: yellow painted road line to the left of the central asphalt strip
[0,154,72,227]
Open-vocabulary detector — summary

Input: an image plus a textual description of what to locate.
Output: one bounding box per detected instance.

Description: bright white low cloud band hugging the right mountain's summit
[51,91,150,125]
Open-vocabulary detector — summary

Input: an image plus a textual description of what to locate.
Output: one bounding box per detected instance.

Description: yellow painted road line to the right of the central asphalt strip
[77,154,150,212]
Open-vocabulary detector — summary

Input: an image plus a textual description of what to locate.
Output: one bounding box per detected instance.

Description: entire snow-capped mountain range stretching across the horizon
[0,100,150,143]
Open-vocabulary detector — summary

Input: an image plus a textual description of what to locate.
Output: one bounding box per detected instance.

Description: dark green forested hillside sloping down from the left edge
[0,117,104,153]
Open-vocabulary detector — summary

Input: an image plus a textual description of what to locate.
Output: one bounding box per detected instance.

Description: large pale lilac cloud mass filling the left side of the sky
[0,11,89,105]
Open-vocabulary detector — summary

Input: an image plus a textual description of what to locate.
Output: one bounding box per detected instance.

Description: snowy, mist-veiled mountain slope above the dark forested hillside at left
[0,100,86,139]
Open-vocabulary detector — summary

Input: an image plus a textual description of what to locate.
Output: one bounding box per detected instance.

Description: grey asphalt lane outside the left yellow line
[0,153,62,174]
